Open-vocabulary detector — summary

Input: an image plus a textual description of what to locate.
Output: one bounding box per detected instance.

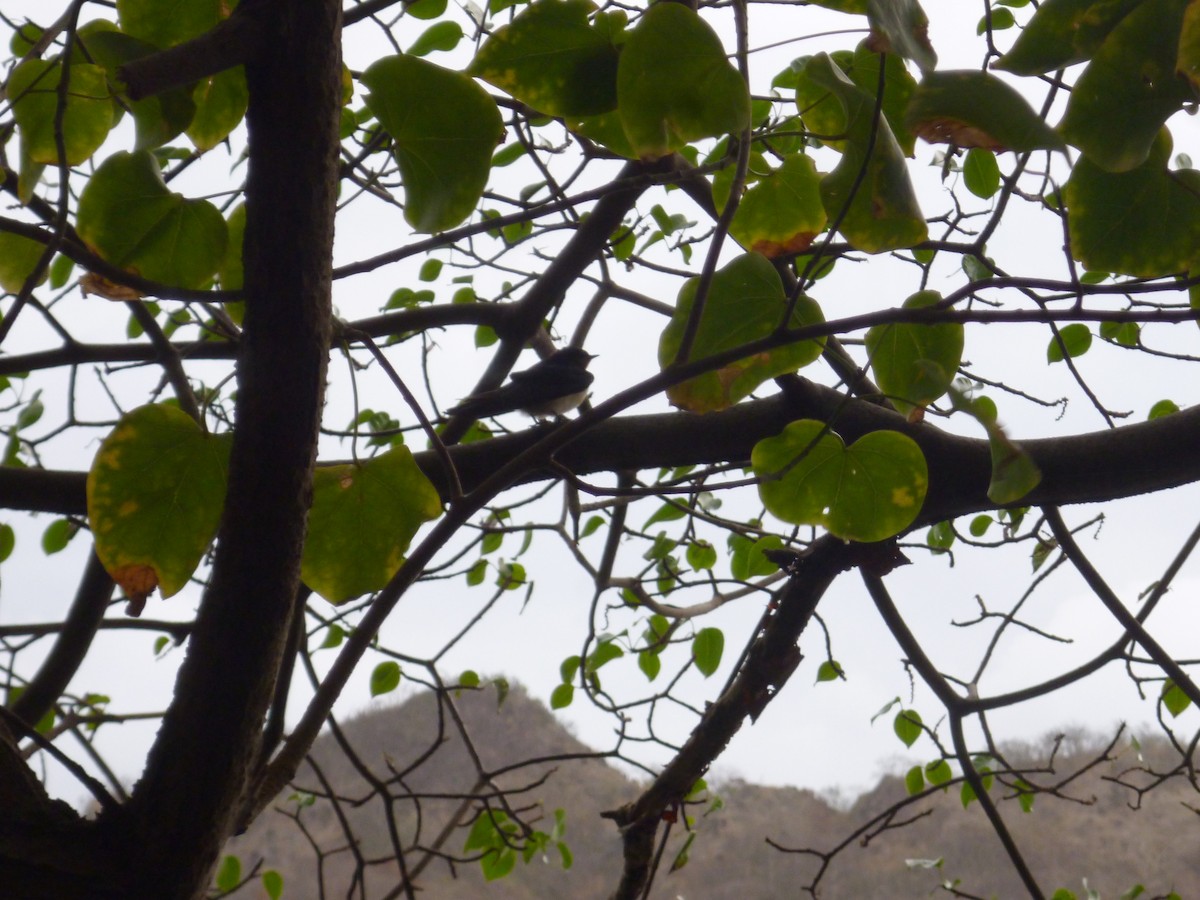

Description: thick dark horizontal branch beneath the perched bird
[7,378,1200,524]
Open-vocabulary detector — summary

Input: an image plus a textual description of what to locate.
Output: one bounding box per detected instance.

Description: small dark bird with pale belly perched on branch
[446,347,595,419]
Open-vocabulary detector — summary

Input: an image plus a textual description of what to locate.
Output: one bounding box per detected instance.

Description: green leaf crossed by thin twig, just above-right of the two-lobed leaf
[866,290,964,413]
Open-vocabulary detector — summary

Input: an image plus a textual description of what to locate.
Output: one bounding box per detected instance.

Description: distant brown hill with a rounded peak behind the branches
[228,688,1200,900]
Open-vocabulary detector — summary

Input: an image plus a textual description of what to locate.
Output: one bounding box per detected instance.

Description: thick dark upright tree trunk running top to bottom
[102,0,342,900]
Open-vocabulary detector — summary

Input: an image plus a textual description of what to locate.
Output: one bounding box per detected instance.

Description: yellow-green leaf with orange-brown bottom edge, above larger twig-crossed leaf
[720,154,826,257]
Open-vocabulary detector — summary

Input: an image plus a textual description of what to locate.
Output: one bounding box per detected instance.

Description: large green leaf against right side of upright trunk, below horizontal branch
[300,446,442,604]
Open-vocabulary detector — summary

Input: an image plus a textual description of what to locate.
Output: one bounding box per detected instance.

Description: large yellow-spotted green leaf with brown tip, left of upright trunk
[88,404,233,607]
